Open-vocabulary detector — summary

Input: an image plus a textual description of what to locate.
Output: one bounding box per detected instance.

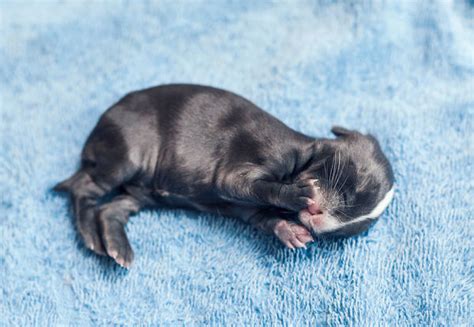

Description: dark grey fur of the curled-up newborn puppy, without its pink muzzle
[56,85,393,266]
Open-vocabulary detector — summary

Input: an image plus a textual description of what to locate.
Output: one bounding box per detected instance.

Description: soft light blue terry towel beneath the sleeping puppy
[0,0,474,326]
